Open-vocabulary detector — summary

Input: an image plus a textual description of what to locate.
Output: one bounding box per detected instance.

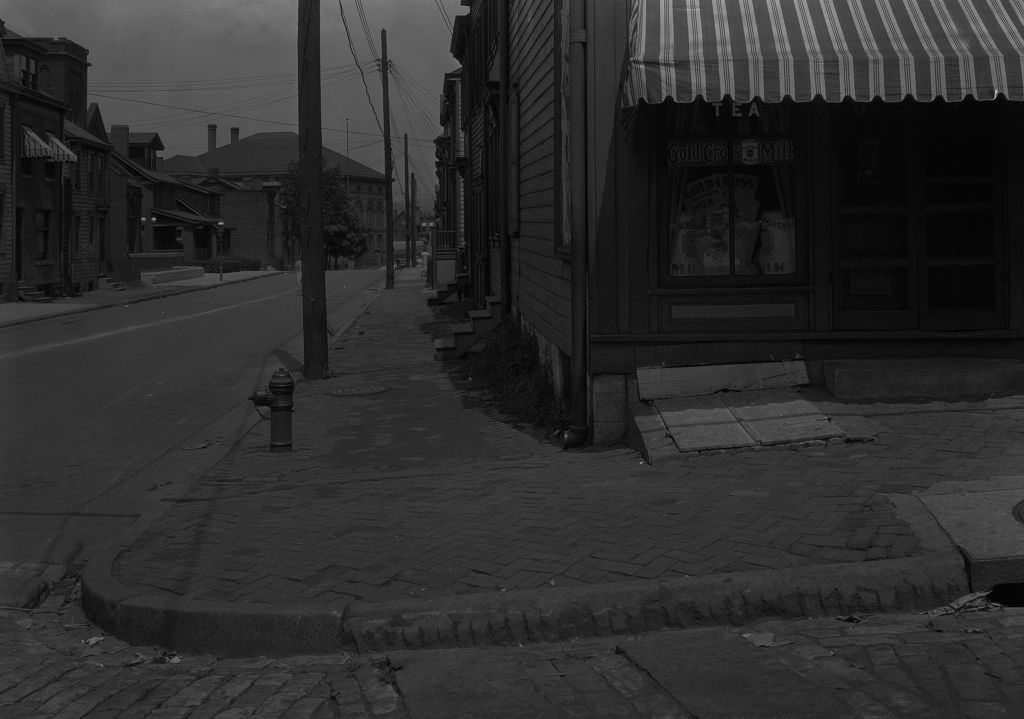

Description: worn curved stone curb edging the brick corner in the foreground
[82,548,968,657]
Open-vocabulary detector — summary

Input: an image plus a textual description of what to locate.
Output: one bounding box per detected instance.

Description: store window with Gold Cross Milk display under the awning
[664,100,798,283]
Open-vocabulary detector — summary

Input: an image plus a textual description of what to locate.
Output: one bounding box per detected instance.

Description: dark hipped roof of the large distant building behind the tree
[190,132,384,180]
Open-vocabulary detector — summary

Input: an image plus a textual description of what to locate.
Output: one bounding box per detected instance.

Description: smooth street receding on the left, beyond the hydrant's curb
[0,270,382,585]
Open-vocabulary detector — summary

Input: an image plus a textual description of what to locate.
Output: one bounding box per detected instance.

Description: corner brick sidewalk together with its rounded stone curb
[84,270,1024,653]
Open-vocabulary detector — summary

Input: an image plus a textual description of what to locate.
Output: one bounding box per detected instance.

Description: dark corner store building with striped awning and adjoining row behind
[444,0,1024,443]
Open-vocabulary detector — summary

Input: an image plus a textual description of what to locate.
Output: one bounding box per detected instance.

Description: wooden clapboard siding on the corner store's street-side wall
[509,0,570,353]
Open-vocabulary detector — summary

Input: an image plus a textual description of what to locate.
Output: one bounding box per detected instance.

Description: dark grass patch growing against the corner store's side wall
[463,322,569,434]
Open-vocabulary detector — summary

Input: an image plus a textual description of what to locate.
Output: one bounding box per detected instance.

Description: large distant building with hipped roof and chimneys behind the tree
[164,124,385,267]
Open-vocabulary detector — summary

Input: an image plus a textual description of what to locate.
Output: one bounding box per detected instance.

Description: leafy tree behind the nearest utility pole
[281,162,369,269]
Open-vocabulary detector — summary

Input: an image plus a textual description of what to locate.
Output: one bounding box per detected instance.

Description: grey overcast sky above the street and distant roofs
[6,0,467,208]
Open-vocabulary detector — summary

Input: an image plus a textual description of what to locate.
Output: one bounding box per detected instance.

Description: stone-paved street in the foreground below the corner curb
[6,582,1024,719]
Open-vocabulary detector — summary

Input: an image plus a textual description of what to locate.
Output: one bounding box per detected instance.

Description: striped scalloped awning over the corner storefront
[624,0,1024,107]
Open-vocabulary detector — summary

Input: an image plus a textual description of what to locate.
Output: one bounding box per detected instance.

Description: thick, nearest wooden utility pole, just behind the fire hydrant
[298,0,328,379]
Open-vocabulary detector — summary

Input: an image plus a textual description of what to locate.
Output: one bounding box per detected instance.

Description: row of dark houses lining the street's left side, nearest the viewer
[0,23,228,300]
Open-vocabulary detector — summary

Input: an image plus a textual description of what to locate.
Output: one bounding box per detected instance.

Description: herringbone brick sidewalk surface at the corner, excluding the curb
[114,270,1024,603]
